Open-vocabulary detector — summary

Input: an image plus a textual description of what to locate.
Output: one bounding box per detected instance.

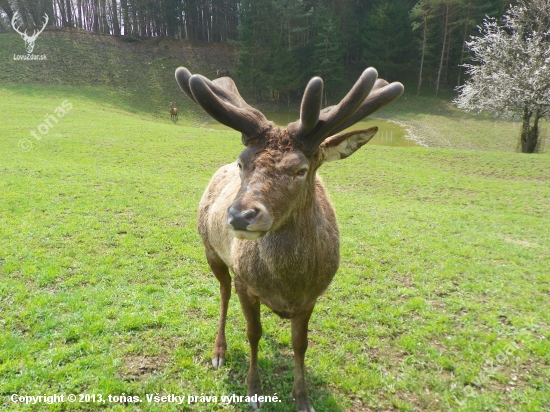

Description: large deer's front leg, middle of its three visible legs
[235,280,262,410]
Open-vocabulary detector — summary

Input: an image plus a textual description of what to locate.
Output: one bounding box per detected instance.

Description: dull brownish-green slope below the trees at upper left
[0,30,235,116]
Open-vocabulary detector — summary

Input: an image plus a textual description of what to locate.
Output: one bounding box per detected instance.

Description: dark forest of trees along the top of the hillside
[0,0,508,103]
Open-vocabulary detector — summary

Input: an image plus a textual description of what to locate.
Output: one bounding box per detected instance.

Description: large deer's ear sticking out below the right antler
[319,127,378,163]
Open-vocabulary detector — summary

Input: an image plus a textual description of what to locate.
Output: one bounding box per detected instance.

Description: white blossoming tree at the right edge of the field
[454,0,550,153]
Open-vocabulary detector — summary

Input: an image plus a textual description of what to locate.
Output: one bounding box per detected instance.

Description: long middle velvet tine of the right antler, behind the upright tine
[303,67,378,153]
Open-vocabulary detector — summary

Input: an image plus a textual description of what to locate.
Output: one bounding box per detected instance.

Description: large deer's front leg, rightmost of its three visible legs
[291,305,315,412]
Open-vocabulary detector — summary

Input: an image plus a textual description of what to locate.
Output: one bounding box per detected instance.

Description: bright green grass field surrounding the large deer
[0,81,550,412]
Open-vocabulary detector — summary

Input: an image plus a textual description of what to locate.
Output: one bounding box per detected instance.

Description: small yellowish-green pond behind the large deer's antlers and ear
[204,113,420,147]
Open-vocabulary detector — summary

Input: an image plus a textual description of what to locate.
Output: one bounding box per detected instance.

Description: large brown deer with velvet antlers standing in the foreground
[176,67,403,412]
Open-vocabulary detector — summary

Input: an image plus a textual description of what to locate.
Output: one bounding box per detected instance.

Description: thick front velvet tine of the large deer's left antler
[189,74,273,145]
